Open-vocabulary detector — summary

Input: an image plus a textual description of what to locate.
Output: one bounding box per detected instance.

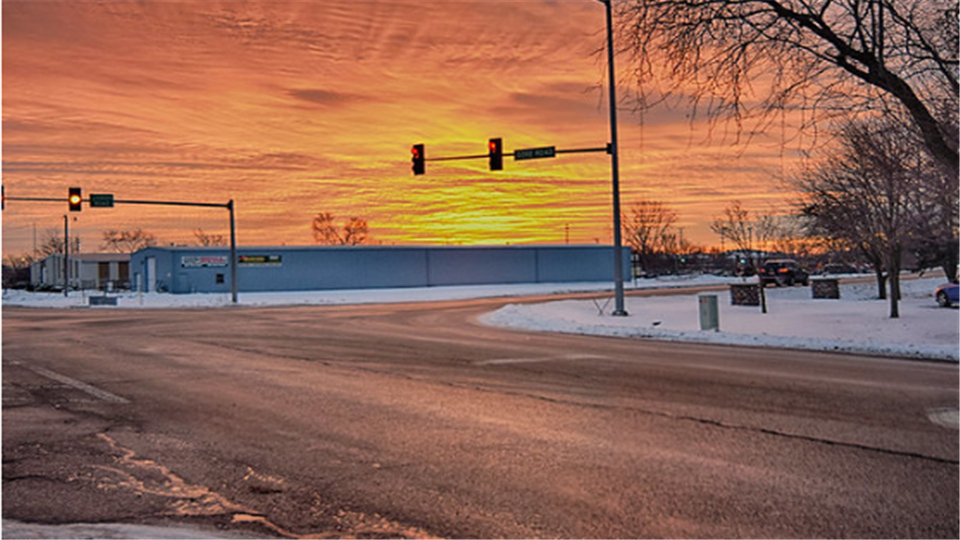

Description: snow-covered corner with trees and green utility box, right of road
[481,278,960,362]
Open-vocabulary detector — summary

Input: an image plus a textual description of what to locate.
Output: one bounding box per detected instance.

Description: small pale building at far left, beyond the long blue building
[30,253,130,290]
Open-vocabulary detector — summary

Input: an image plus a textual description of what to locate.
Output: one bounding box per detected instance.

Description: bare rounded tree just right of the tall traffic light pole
[622,200,678,272]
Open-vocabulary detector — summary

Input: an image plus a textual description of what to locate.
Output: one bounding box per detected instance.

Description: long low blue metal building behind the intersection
[130,245,630,294]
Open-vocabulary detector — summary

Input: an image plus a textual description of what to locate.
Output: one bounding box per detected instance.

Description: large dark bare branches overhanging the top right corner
[620,0,960,173]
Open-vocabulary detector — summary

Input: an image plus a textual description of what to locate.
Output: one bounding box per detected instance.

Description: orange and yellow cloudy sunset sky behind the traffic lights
[2,0,795,256]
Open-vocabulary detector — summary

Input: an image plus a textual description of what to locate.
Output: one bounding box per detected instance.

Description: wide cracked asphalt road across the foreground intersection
[3,299,960,538]
